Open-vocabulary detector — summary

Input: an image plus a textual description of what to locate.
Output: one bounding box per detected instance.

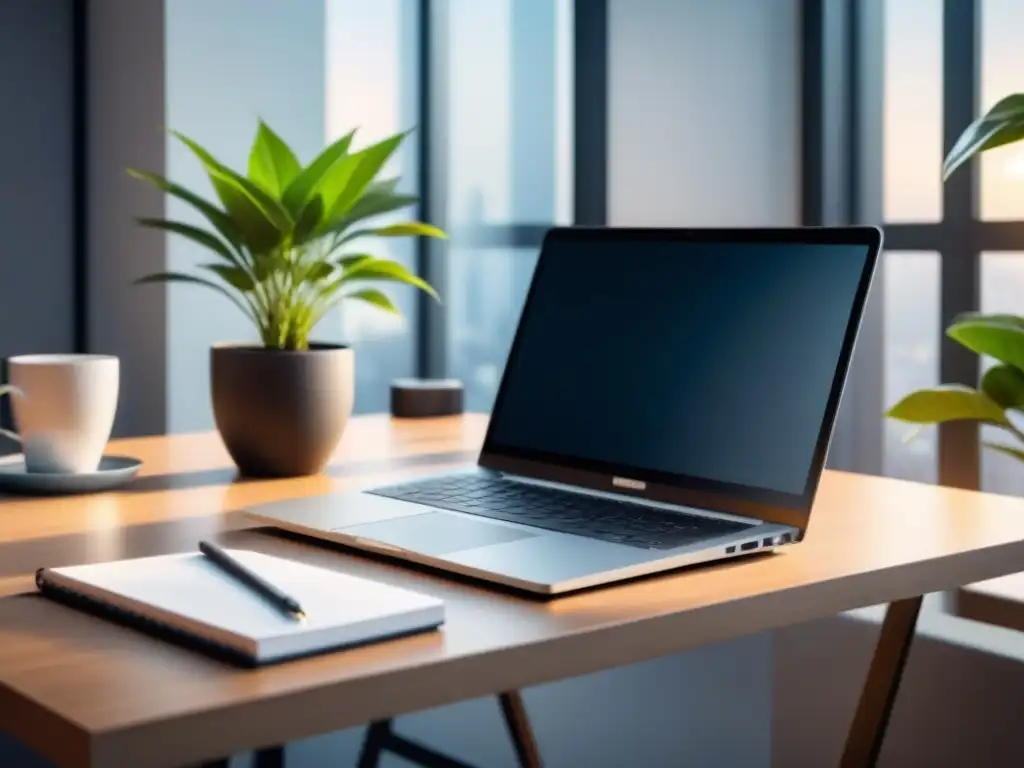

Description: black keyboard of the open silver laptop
[369,475,754,549]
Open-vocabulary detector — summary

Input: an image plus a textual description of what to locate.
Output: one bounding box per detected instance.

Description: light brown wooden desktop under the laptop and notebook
[6,416,1024,766]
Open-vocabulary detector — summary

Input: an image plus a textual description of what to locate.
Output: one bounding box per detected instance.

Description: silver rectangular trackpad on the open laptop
[335,512,536,555]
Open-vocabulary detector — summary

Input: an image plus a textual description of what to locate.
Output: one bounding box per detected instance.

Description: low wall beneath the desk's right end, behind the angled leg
[772,606,1024,768]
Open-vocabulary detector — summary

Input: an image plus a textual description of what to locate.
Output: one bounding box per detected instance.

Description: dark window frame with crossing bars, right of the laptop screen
[803,0,1024,489]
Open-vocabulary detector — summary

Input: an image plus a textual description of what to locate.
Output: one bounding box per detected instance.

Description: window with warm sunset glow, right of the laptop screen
[822,0,1024,494]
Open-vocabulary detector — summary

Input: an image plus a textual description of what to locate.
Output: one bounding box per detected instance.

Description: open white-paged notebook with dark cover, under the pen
[36,550,444,667]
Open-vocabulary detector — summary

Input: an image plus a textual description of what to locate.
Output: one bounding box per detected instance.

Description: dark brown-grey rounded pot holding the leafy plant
[210,344,355,477]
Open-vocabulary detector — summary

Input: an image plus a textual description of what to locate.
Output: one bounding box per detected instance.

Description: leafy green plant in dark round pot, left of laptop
[129,121,444,477]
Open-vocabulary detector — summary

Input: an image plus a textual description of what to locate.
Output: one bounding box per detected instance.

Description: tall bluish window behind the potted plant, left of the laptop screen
[158,0,593,431]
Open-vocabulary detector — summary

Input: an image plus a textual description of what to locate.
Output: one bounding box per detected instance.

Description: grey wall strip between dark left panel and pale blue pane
[86,0,167,435]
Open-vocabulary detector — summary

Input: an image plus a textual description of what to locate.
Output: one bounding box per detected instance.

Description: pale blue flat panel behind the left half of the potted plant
[164,0,329,432]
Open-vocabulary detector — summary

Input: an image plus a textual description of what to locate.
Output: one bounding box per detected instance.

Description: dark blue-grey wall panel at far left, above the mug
[0,0,75,453]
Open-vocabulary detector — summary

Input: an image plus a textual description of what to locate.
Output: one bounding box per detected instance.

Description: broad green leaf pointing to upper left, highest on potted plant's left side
[171,131,293,253]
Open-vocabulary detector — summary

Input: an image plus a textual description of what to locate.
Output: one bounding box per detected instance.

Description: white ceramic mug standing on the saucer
[7,354,121,474]
